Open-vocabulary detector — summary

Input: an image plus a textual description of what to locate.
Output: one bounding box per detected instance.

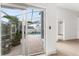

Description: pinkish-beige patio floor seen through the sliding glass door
[6,35,44,56]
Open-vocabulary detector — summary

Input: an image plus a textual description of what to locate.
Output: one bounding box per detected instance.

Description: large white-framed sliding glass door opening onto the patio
[0,4,45,56]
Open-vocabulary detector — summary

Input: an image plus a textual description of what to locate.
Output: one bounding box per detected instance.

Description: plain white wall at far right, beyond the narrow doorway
[57,8,79,39]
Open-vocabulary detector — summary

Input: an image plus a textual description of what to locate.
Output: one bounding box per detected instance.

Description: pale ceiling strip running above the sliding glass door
[1,3,43,11]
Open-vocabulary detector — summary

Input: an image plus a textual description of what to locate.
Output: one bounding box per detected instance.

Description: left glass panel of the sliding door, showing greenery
[1,7,22,56]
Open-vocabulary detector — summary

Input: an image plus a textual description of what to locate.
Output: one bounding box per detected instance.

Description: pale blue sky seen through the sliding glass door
[1,8,40,21]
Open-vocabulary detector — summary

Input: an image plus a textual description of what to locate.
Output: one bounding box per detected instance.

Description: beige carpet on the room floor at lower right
[54,39,79,56]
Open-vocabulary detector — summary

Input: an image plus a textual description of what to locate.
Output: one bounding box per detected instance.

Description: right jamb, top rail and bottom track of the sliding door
[26,4,46,55]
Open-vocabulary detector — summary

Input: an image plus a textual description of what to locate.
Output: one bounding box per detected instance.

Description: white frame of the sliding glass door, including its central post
[0,3,46,56]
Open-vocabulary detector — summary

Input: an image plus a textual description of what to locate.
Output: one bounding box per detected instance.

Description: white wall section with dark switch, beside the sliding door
[30,3,57,54]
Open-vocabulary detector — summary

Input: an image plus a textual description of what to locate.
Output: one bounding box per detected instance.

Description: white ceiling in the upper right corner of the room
[57,3,79,12]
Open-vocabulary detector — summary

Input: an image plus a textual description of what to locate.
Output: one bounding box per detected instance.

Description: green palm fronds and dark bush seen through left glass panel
[3,15,22,46]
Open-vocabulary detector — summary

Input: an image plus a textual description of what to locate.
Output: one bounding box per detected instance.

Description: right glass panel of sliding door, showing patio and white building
[27,8,44,55]
